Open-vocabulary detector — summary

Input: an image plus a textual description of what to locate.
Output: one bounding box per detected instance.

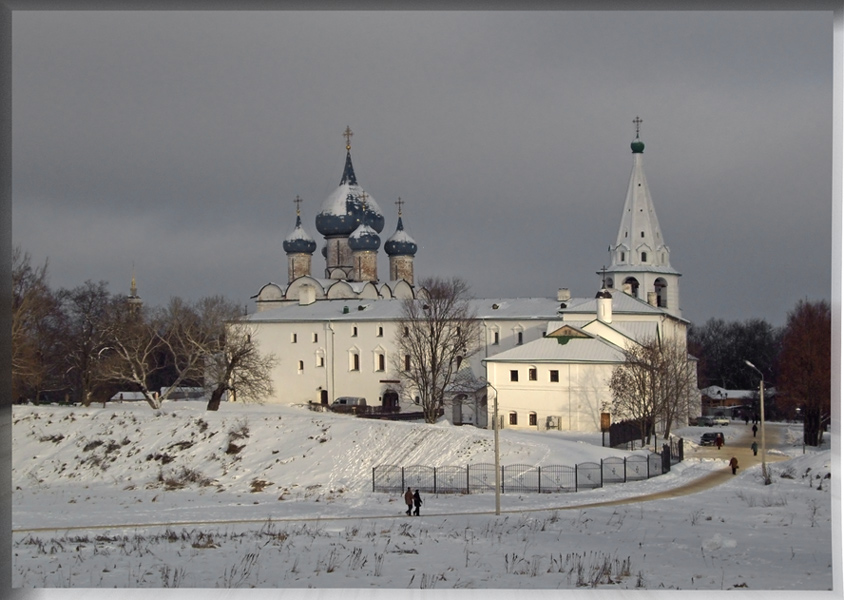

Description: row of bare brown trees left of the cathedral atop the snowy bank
[12,247,275,410]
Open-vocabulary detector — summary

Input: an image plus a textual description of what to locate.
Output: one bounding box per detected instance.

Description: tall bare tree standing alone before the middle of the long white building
[393,278,480,423]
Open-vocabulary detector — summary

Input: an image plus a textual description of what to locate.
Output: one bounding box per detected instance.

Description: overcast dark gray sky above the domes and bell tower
[12,11,833,325]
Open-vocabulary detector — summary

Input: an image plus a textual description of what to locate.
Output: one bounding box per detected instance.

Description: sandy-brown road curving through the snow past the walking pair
[12,421,788,533]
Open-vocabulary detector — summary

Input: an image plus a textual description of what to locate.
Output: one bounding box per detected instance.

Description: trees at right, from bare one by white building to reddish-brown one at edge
[605,300,831,445]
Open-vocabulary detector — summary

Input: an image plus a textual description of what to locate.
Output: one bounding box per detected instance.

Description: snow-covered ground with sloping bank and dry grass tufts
[12,401,833,590]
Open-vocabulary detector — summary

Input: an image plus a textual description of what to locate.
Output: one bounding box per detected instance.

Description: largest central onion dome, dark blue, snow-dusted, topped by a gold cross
[316,127,384,236]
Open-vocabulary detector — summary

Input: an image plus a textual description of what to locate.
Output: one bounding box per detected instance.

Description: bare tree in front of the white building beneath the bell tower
[605,339,697,444]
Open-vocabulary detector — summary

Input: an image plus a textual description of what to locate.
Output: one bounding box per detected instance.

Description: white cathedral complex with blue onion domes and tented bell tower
[236,123,699,431]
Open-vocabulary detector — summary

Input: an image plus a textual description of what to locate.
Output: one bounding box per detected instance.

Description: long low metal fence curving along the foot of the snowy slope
[372,454,670,494]
